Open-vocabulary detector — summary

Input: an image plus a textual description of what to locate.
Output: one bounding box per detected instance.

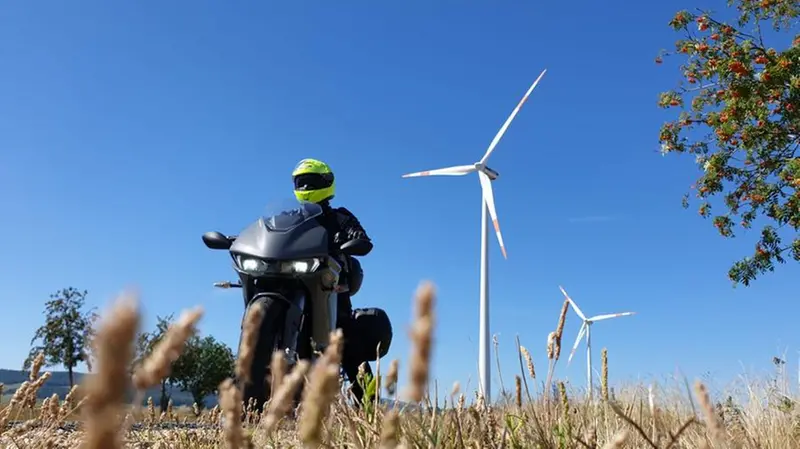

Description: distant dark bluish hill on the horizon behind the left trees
[0,369,217,407]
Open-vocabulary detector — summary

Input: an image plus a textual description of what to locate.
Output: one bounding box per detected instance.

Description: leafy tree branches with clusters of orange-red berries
[656,0,800,286]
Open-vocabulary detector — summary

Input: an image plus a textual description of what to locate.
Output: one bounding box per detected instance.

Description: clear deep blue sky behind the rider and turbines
[0,0,800,400]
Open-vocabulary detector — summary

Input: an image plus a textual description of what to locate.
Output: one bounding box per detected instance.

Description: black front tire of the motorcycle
[239,297,287,411]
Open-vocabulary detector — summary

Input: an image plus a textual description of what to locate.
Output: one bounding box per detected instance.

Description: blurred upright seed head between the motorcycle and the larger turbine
[409,282,435,403]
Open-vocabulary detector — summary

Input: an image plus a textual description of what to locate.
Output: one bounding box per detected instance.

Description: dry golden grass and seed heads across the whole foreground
[0,278,800,449]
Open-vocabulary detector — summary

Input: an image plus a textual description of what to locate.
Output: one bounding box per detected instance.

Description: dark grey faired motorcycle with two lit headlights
[203,201,372,409]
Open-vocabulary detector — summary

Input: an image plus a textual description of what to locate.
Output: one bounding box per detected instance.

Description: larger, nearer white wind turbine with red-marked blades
[403,69,547,404]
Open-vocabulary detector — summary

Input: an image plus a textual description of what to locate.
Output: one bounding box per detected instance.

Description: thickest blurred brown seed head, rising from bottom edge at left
[83,295,140,449]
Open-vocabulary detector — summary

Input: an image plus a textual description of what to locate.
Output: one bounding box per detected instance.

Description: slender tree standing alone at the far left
[23,287,96,387]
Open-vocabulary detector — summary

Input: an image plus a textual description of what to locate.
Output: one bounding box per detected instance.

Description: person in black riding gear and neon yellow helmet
[292,159,380,401]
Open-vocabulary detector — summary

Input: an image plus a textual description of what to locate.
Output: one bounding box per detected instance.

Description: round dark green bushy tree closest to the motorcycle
[172,336,234,408]
